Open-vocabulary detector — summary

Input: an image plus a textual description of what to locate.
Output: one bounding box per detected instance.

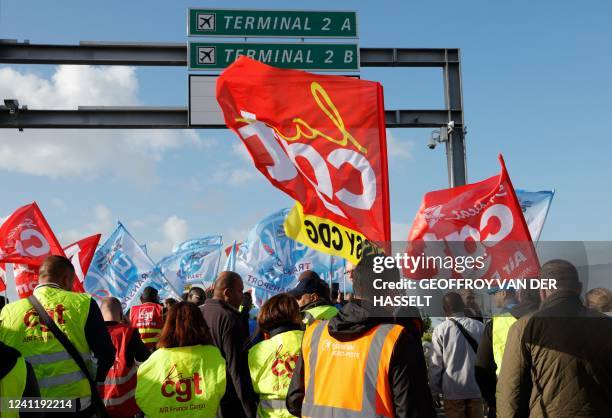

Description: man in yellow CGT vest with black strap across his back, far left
[0,255,115,416]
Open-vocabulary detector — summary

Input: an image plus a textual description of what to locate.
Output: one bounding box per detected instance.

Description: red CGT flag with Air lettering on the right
[404,155,539,280]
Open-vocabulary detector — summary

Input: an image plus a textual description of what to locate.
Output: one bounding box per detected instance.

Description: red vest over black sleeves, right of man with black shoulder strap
[102,324,140,418]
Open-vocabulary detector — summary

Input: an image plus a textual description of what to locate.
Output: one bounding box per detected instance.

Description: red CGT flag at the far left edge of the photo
[0,202,64,265]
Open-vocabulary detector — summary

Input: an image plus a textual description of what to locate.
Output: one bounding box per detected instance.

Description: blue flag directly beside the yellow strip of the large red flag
[234,208,345,304]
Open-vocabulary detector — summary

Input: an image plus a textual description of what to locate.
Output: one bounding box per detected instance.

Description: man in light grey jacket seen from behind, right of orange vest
[429,292,483,418]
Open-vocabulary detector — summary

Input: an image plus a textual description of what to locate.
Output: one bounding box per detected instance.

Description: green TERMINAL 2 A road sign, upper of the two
[187,9,357,38]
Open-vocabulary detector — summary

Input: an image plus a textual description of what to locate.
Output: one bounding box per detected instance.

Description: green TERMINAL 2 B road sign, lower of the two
[189,42,359,71]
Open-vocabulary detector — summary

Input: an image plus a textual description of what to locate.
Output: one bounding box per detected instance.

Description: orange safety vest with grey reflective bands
[302,321,403,418]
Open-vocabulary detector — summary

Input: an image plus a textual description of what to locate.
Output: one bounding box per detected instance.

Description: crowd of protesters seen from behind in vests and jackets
[0,256,612,418]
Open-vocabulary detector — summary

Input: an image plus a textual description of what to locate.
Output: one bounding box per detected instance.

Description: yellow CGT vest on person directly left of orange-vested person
[249,330,304,418]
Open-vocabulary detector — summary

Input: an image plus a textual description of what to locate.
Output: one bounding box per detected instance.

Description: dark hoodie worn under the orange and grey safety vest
[286,300,436,418]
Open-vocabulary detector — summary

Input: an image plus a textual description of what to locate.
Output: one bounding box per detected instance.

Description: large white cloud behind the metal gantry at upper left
[0,65,216,183]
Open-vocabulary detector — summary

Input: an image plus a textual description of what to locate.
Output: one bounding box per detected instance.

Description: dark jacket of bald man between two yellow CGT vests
[200,299,258,418]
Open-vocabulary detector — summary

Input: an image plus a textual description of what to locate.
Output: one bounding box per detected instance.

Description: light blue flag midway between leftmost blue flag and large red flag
[157,235,223,290]
